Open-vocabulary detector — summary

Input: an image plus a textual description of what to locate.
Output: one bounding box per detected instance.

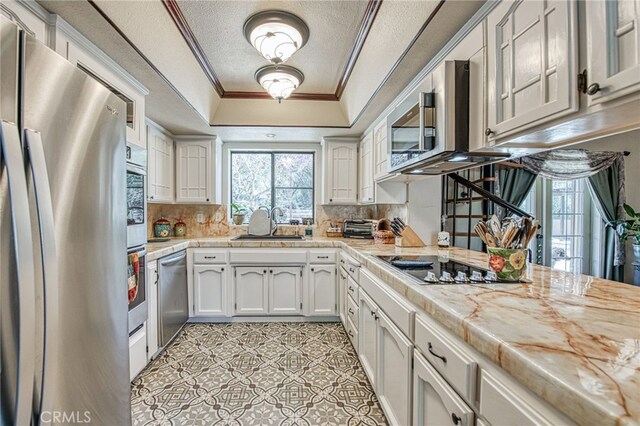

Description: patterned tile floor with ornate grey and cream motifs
[131,323,387,426]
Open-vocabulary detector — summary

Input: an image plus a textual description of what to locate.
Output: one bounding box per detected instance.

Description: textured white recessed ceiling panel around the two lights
[178,0,368,93]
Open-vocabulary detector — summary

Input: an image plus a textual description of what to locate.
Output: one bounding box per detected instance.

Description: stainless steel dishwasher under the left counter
[158,250,189,347]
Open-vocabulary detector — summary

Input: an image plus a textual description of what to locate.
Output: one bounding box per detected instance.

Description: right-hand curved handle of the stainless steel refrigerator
[24,129,59,425]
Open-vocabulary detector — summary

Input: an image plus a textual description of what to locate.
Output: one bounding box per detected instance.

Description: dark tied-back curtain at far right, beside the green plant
[588,157,625,282]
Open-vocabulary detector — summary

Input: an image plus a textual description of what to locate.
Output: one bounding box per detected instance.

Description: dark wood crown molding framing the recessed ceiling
[162,0,383,101]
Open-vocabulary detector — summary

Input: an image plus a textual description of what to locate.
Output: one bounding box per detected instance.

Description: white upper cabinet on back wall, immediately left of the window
[175,137,221,204]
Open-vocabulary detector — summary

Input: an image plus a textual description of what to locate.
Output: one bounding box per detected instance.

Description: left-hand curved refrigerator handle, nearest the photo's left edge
[0,121,36,425]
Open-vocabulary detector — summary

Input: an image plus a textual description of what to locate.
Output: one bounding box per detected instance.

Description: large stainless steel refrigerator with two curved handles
[0,16,131,425]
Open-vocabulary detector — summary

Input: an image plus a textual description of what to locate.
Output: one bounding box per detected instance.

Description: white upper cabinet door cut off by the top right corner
[585,0,640,105]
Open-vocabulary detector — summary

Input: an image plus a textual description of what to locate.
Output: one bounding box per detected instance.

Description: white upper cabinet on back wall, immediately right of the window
[322,139,358,204]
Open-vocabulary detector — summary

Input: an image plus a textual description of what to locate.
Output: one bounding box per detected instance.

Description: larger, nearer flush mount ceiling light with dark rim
[244,10,309,65]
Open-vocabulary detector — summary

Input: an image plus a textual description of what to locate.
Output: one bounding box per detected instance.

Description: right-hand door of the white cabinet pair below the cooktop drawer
[376,310,413,426]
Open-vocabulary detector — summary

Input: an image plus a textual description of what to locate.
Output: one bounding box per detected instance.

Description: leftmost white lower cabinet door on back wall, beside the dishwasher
[193,265,228,316]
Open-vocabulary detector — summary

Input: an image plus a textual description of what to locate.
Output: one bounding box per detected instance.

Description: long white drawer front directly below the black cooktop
[359,269,415,339]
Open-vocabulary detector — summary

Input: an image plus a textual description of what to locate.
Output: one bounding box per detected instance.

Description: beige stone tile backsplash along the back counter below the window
[147,203,407,238]
